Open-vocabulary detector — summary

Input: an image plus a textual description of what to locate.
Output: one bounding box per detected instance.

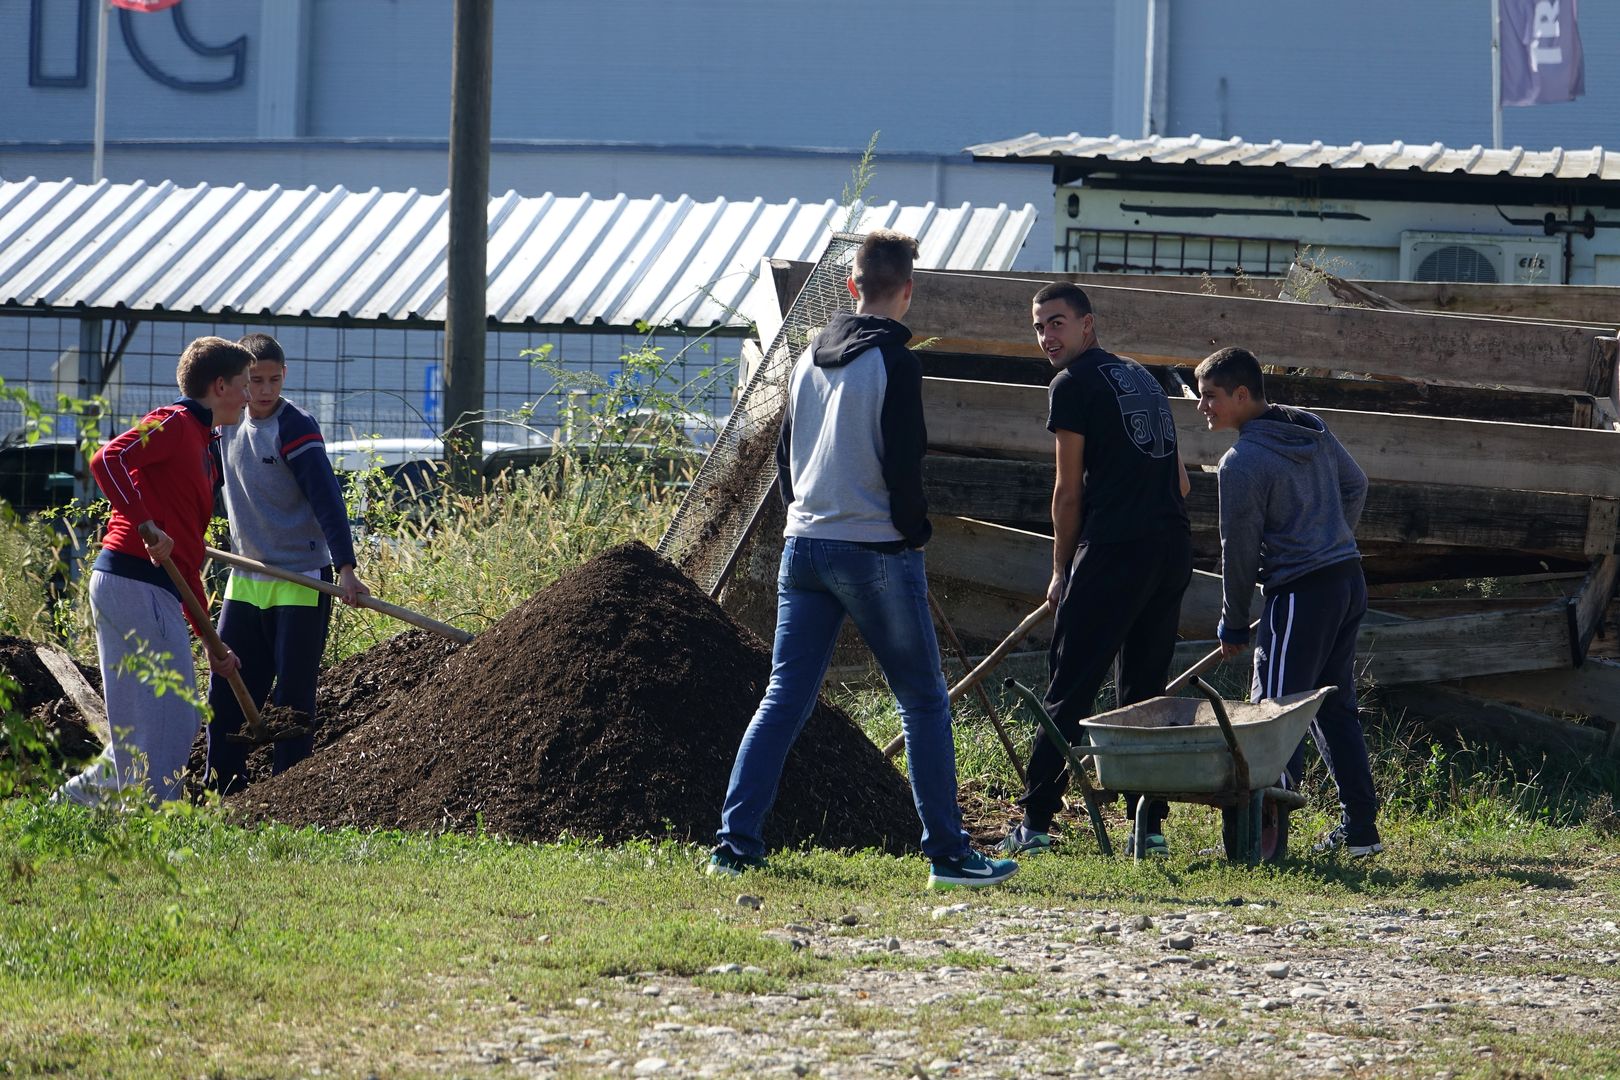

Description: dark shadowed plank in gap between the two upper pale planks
[917,348,1601,427]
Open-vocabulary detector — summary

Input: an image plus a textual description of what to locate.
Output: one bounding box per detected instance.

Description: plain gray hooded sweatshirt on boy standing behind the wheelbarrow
[1217,405,1367,644]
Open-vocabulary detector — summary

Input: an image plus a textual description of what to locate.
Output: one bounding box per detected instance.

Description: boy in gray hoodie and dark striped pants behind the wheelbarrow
[1197,348,1383,855]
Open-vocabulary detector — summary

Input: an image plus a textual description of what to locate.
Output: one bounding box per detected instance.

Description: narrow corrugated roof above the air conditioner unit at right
[967,133,1620,180]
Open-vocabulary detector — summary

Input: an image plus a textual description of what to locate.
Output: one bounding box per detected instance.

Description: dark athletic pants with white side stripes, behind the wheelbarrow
[1249,559,1379,842]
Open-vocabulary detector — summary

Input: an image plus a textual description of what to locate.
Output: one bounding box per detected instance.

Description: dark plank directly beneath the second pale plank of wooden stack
[923,455,1620,559]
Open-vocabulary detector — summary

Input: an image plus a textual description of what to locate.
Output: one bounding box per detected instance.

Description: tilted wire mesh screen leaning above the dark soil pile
[658,233,863,596]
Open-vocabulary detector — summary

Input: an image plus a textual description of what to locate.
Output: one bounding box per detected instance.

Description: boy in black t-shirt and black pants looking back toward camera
[1001,282,1192,855]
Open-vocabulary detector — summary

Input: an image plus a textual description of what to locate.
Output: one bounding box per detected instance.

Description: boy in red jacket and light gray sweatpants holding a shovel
[62,337,253,806]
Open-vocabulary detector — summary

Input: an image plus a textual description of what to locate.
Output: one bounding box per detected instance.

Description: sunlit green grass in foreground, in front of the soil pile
[0,800,1620,1077]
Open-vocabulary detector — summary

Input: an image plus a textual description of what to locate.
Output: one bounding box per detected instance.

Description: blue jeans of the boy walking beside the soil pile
[718,536,970,858]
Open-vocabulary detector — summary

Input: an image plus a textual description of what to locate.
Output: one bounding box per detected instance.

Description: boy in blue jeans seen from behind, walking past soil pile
[706,228,1017,889]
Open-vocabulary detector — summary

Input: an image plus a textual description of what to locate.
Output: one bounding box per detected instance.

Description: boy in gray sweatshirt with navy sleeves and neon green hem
[204,334,371,793]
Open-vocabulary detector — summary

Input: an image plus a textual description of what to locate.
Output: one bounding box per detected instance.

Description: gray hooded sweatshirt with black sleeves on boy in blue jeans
[776,314,933,547]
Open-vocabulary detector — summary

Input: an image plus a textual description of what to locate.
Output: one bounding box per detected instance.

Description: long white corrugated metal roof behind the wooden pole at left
[0,180,1035,327]
